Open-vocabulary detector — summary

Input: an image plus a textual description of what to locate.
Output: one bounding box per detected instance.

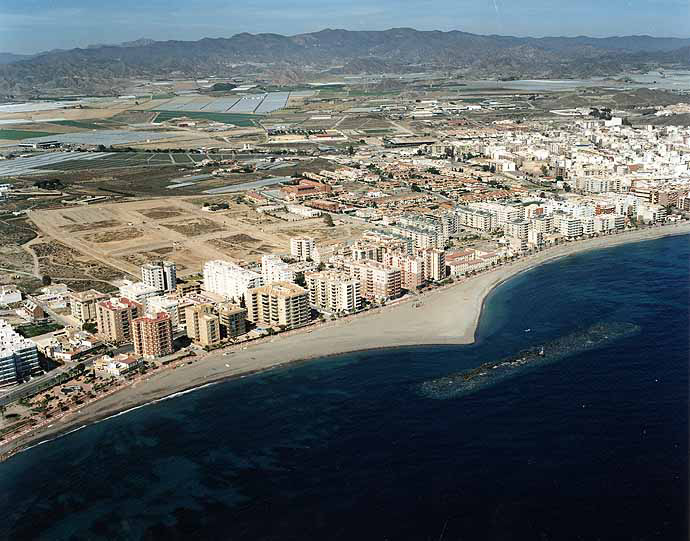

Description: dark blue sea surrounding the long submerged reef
[0,236,690,541]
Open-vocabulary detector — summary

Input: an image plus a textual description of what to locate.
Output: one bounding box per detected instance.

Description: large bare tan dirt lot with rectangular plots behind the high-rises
[28,196,364,276]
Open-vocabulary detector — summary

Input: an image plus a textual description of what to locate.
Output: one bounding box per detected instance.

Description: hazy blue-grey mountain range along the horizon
[0,28,690,95]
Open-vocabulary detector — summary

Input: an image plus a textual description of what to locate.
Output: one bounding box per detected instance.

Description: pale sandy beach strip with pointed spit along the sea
[0,222,690,460]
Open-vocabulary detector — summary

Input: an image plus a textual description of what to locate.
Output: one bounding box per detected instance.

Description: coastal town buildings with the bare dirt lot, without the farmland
[0,83,690,448]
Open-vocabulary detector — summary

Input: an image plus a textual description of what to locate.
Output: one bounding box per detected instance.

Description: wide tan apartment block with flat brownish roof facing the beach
[244,282,311,330]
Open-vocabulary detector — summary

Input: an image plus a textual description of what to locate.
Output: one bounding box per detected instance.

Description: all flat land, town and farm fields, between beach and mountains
[0,74,690,450]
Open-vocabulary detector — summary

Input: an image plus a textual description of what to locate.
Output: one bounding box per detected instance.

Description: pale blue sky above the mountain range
[0,0,690,54]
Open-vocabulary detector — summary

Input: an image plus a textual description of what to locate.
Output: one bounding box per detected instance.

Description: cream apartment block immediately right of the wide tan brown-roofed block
[304,271,362,312]
